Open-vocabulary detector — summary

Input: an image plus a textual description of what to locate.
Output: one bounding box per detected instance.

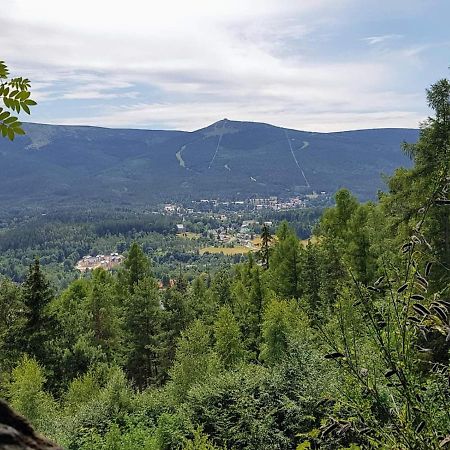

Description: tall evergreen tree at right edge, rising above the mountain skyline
[383,79,450,289]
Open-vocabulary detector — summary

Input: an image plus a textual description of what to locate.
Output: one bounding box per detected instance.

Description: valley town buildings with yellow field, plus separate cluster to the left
[76,192,330,272]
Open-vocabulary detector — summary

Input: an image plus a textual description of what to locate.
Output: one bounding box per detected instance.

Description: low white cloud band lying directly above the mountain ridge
[47,85,422,131]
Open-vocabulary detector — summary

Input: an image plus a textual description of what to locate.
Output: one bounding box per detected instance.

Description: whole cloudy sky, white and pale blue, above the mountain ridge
[0,0,450,131]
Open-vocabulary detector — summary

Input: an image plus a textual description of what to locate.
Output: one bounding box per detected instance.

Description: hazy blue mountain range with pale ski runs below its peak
[0,119,418,211]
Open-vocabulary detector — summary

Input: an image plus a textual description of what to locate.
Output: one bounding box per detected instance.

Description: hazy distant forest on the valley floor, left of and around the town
[0,205,323,291]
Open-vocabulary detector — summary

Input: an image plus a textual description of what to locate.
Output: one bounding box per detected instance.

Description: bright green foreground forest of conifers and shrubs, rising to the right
[0,79,450,450]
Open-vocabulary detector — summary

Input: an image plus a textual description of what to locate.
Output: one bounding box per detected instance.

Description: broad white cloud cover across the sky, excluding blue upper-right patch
[0,0,434,130]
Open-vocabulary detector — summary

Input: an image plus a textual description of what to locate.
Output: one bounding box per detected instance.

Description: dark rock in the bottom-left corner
[0,400,62,450]
